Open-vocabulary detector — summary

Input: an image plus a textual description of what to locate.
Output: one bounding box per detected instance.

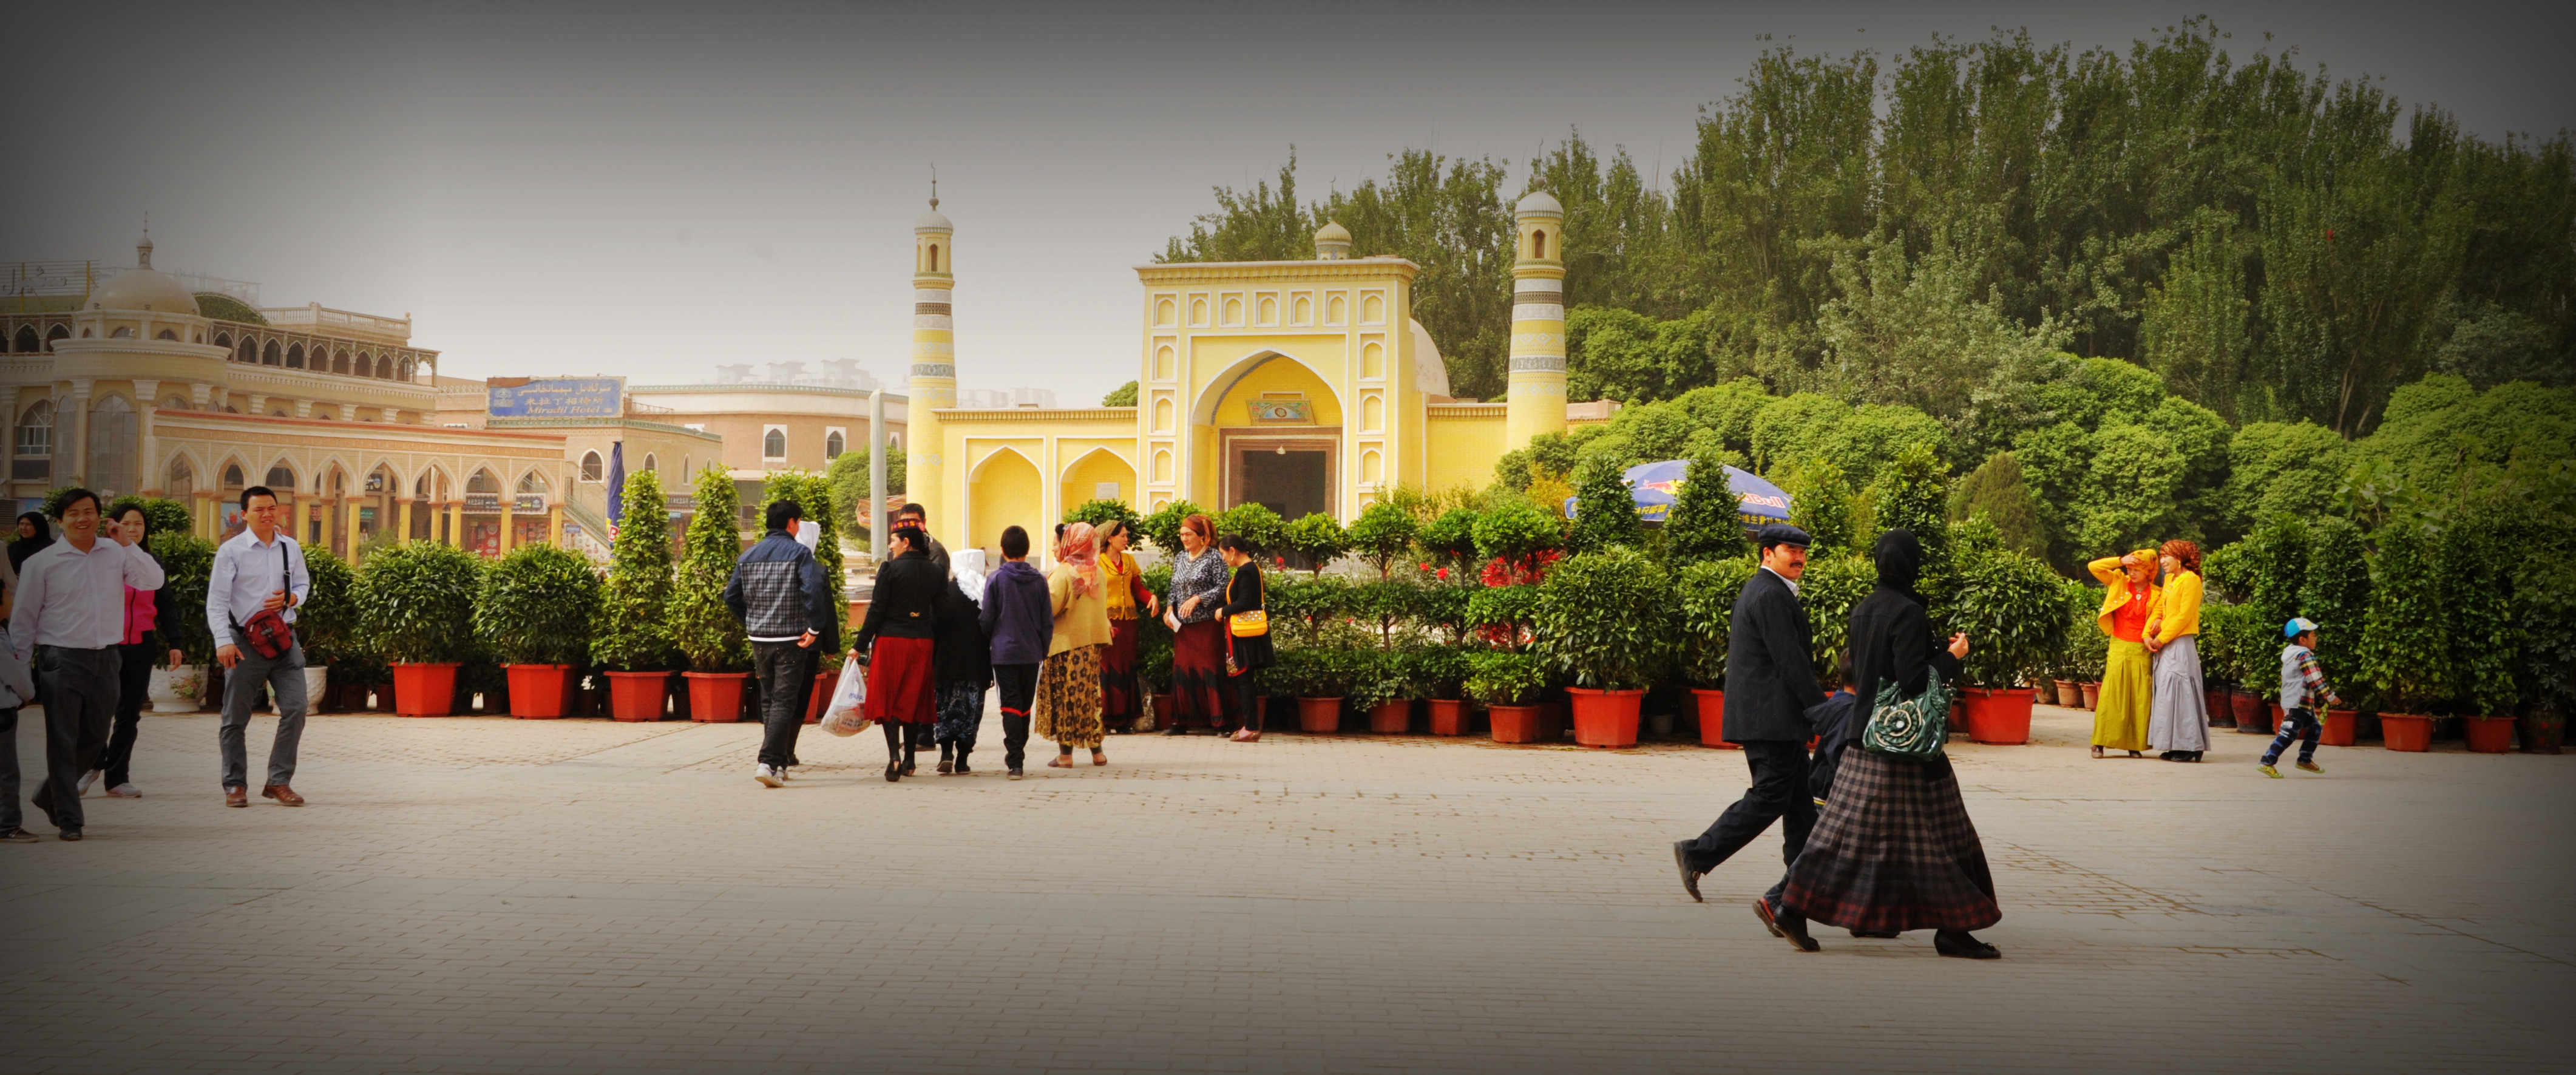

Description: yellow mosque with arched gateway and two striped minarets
[907,194,1610,549]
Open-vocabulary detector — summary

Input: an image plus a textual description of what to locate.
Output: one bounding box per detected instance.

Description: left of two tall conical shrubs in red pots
[590,469,675,722]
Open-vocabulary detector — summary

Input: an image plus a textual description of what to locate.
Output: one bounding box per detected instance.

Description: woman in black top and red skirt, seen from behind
[850,518,948,784]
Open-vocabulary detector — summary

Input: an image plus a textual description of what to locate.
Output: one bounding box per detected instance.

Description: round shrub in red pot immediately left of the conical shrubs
[474,544,600,719]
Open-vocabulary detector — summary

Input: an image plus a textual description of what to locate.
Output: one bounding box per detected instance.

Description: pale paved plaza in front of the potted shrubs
[0,707,2576,1073]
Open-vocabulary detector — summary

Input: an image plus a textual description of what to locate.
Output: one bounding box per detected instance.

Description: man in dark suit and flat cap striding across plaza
[1672,526,1824,951]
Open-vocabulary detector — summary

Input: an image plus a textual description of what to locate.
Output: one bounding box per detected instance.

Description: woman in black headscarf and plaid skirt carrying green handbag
[1780,531,2004,959]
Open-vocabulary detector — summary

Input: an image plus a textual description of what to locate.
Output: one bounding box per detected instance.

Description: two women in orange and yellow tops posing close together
[2087,541,2210,761]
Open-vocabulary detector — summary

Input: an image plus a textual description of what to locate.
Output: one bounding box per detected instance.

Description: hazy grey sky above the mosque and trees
[0,0,2576,405]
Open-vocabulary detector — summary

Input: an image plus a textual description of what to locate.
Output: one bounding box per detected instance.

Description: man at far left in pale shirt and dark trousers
[10,490,162,841]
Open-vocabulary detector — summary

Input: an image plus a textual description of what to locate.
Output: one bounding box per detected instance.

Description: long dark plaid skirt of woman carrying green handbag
[1780,748,2004,933]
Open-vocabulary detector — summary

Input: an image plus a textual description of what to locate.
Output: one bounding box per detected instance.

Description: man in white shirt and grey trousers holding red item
[206,484,314,807]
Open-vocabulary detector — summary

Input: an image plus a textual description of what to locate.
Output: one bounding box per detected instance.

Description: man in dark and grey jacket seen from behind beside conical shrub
[724,500,832,789]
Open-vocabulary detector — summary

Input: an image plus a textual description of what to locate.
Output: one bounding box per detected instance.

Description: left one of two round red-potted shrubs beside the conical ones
[356,541,482,717]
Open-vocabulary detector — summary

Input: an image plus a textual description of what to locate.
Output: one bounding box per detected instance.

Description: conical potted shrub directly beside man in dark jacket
[669,467,752,724]
